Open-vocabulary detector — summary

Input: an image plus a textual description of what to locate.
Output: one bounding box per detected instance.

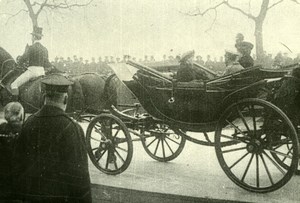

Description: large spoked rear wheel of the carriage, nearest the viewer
[215,99,298,192]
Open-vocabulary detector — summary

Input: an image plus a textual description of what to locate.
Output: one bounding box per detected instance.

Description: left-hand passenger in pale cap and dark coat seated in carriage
[177,50,208,82]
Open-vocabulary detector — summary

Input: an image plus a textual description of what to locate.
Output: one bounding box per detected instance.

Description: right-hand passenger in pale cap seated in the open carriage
[223,51,244,75]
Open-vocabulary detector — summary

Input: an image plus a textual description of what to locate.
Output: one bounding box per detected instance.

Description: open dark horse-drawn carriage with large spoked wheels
[86,62,299,192]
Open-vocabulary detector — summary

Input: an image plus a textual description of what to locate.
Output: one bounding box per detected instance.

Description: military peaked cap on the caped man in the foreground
[41,74,73,93]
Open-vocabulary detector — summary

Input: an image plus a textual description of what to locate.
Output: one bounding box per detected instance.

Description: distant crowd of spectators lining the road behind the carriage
[51,52,300,74]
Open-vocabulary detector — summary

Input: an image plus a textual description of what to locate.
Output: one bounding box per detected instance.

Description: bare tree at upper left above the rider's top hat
[0,0,94,32]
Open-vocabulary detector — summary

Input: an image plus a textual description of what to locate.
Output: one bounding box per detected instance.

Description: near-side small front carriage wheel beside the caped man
[86,114,133,175]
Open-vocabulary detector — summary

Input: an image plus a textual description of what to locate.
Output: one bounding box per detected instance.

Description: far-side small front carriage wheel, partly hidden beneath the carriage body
[142,123,186,162]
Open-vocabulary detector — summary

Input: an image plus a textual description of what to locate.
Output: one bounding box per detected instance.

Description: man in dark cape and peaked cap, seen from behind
[13,74,91,202]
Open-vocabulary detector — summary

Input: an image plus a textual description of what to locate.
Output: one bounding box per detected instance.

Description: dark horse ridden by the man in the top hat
[0,47,117,115]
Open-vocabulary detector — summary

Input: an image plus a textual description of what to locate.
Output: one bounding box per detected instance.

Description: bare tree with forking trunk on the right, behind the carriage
[187,0,300,60]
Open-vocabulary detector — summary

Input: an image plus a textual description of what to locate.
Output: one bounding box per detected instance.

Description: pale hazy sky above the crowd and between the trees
[0,0,300,60]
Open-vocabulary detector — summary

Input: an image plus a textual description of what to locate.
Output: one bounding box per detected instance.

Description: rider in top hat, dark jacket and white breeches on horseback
[11,27,52,97]
